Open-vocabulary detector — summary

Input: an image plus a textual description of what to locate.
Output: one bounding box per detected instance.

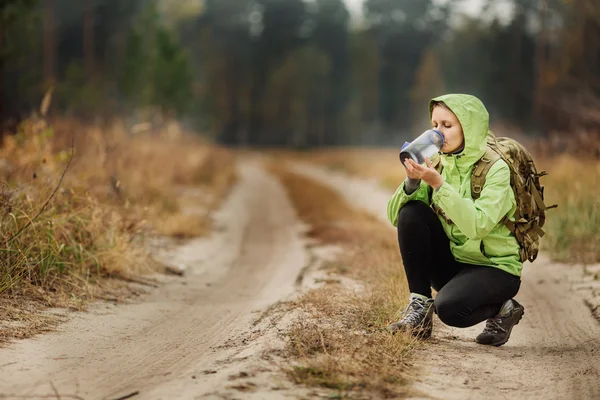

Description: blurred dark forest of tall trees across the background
[0,0,600,148]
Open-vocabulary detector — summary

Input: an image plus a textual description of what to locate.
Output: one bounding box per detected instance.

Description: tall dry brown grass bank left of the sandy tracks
[0,118,234,342]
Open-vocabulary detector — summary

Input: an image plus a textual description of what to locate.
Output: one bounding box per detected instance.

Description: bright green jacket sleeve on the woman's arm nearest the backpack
[432,160,516,240]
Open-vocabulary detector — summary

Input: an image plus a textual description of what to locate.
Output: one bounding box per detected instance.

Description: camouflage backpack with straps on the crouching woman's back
[433,131,557,262]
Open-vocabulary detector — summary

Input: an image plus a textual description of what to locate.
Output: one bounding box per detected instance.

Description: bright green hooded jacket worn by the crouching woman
[387,94,523,276]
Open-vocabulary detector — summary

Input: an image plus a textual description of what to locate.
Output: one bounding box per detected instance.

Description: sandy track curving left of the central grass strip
[0,161,308,399]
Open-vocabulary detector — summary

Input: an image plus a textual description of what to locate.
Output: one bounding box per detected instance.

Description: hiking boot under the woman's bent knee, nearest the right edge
[475,299,525,346]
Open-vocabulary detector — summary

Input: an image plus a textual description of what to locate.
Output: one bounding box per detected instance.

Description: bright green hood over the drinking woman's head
[429,94,489,170]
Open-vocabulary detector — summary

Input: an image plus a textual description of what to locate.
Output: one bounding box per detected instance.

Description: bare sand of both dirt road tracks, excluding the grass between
[0,160,600,400]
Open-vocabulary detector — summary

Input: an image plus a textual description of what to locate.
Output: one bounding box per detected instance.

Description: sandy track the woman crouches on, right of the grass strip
[296,165,600,399]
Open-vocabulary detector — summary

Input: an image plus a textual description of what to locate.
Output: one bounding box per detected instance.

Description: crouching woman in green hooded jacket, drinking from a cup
[387,94,524,346]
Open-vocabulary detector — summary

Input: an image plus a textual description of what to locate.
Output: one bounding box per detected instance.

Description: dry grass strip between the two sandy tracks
[272,164,413,398]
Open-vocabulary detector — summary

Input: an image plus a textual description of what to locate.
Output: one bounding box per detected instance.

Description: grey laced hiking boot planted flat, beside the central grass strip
[388,293,433,339]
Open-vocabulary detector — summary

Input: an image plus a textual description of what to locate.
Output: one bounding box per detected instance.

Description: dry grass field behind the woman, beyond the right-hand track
[301,149,600,263]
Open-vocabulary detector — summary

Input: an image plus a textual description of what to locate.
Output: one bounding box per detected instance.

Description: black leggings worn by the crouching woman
[398,201,521,328]
